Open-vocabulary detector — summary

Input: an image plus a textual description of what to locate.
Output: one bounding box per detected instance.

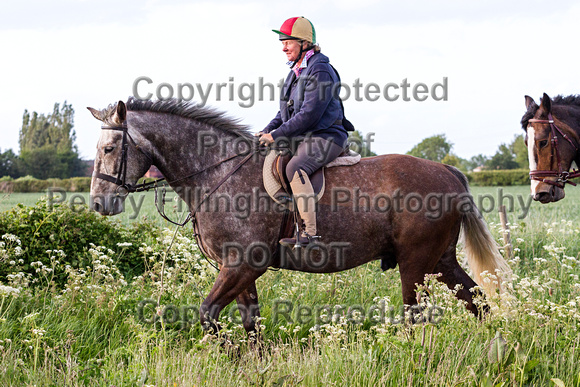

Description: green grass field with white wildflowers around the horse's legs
[0,186,580,387]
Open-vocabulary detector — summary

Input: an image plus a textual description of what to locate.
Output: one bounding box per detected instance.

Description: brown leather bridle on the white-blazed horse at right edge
[528,113,580,189]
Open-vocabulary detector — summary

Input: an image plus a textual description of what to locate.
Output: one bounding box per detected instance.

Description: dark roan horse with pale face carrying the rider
[88,97,509,335]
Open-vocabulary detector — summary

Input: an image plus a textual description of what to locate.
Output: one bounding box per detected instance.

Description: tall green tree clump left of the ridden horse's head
[19,101,83,179]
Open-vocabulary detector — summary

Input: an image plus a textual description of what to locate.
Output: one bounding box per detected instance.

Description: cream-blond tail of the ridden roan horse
[447,166,512,296]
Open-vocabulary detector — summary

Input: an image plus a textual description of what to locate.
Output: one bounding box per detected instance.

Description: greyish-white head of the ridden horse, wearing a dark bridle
[87,101,151,215]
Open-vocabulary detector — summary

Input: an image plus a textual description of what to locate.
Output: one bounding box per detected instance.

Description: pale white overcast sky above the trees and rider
[0,0,580,159]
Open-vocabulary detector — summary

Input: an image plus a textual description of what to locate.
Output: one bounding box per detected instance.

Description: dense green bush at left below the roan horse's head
[0,199,160,286]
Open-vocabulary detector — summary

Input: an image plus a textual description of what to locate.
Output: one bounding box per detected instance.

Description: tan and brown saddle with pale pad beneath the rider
[263,148,361,205]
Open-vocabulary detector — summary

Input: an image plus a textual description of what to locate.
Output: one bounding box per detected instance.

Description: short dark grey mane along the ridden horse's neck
[101,97,252,137]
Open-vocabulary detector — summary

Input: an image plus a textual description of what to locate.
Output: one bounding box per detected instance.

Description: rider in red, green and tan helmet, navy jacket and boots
[257,17,348,246]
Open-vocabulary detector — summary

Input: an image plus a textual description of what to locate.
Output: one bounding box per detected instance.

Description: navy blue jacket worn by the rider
[263,52,348,146]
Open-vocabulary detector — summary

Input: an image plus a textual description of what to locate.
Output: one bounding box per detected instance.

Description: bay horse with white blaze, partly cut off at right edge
[521,93,580,204]
